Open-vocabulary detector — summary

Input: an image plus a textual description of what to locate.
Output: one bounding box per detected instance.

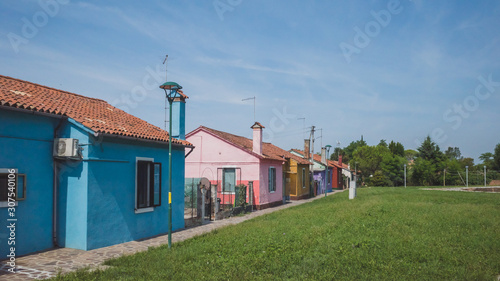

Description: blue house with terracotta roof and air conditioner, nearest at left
[0,76,193,259]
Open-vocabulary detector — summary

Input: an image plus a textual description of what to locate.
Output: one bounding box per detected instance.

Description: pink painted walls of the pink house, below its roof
[185,130,283,205]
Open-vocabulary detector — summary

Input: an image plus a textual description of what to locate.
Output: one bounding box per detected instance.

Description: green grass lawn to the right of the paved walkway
[57,188,500,280]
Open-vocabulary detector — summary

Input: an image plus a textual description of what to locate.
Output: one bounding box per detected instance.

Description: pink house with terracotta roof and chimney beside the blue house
[186,122,288,209]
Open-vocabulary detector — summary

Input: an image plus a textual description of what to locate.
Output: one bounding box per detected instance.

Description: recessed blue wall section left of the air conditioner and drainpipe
[0,110,59,259]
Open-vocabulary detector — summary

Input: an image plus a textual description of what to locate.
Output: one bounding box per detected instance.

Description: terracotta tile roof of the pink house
[198,123,310,164]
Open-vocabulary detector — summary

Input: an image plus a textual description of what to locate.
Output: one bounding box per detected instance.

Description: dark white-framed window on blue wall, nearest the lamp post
[135,158,161,211]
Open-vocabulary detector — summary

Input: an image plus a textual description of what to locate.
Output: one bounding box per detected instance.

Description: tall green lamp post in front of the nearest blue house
[160,82,182,249]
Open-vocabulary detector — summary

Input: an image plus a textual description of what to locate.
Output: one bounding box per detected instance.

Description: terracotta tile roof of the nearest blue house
[0,75,191,146]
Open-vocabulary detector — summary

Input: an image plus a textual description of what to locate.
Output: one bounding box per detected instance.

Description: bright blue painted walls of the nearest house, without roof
[0,107,188,257]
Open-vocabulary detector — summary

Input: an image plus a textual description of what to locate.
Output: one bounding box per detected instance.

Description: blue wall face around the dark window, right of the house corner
[87,135,184,250]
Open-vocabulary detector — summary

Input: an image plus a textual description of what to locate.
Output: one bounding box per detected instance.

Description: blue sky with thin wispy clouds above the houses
[0,0,500,162]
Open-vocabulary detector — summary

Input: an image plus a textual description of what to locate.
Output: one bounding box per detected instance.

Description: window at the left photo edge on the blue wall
[0,169,26,207]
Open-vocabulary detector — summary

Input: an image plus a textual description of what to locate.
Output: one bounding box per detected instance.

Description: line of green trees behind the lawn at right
[330,136,500,186]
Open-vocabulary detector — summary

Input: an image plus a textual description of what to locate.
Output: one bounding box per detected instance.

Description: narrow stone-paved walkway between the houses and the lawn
[0,190,342,281]
